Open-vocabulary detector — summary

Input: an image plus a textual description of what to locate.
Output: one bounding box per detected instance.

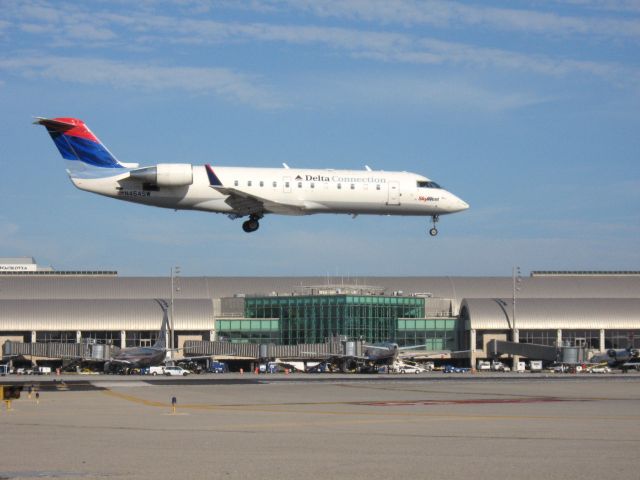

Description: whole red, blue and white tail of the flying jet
[34,117,138,177]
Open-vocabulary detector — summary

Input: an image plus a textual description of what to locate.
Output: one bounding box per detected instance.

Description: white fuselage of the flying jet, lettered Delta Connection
[71,165,469,216]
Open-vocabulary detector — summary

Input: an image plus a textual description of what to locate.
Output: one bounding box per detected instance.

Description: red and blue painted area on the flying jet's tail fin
[35,118,128,168]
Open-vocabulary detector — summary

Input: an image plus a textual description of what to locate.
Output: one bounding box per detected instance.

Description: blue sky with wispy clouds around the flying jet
[0,0,640,276]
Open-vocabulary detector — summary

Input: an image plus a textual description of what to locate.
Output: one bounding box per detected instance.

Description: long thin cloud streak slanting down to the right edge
[122,17,640,85]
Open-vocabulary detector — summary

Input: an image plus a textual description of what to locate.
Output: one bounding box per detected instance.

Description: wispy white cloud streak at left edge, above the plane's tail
[0,57,283,109]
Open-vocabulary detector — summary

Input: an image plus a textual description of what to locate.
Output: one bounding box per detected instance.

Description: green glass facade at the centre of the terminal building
[242,295,425,345]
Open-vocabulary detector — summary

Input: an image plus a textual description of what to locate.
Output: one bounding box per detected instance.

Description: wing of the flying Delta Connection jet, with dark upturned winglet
[205,165,306,216]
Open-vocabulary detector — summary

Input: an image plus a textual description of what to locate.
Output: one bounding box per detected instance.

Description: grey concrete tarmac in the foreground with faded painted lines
[0,373,640,480]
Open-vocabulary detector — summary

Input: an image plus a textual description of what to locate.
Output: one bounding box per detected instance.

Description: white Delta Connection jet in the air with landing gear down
[34,117,469,236]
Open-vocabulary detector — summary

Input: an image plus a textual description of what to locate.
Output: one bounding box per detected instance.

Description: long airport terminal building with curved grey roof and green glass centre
[0,258,640,365]
